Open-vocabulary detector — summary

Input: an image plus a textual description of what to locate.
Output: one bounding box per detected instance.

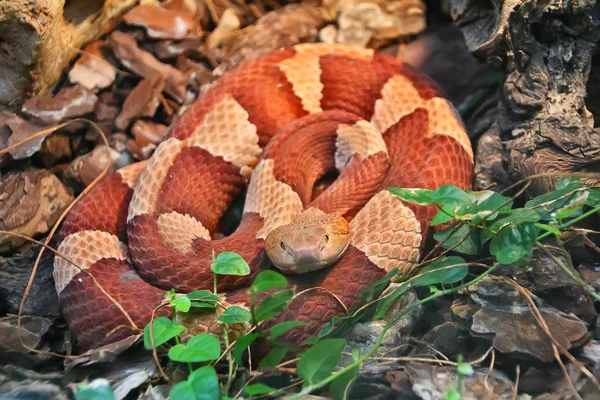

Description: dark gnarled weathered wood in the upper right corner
[451,0,600,192]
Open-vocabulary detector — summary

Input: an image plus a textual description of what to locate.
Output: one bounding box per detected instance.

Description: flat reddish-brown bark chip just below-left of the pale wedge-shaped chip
[21,85,98,125]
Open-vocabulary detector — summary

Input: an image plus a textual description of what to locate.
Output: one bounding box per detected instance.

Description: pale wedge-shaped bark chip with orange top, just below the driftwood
[69,40,117,90]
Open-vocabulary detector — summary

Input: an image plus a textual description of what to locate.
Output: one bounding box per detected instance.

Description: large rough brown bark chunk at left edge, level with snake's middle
[0,170,73,253]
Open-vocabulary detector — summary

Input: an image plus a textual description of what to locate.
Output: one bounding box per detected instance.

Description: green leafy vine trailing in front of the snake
[139,178,600,400]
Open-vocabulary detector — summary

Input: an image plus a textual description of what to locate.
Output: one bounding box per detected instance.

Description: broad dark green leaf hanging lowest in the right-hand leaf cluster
[490,222,540,264]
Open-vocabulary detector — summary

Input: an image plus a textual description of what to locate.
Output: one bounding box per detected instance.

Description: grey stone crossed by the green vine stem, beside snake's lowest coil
[339,284,423,366]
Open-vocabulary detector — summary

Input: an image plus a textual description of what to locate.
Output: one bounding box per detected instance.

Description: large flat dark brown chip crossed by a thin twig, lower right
[457,276,589,362]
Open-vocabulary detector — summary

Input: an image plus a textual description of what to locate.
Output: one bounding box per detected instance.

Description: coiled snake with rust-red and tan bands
[53,43,473,350]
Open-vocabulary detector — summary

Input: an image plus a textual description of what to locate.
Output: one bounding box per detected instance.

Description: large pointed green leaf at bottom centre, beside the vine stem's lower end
[296,339,346,386]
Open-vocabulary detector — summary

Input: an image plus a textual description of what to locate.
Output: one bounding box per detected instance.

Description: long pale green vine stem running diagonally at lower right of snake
[286,264,499,400]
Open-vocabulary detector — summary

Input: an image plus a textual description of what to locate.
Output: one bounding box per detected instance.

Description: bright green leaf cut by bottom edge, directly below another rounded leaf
[169,365,219,400]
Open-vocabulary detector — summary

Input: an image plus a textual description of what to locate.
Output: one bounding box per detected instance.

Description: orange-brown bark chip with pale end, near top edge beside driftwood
[123,4,198,39]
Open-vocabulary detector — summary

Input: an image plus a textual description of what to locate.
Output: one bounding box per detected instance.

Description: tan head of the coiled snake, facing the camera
[265,207,350,274]
